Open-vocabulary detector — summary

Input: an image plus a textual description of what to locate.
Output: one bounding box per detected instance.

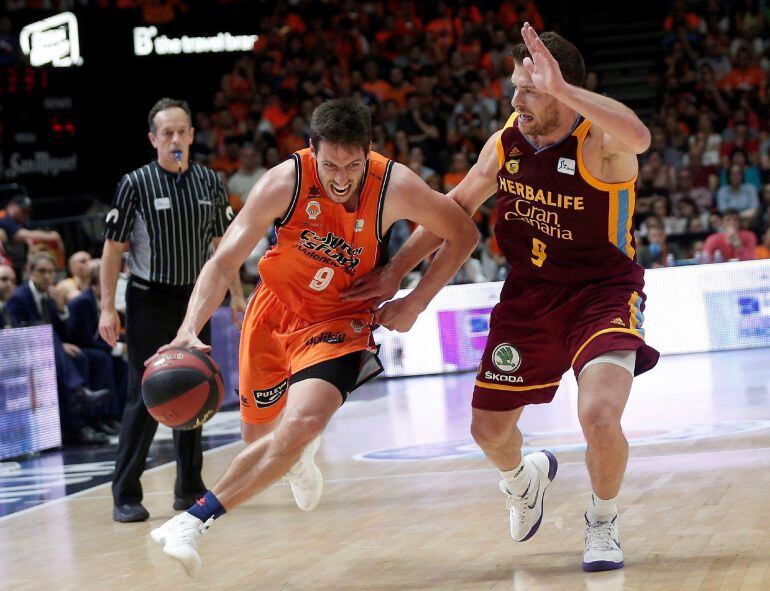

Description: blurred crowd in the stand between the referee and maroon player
[183,0,544,283]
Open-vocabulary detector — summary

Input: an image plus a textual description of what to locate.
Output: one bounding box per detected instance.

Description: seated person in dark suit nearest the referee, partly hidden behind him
[67,264,128,435]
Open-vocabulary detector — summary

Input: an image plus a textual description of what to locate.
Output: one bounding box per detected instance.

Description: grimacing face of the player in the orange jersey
[315,142,368,203]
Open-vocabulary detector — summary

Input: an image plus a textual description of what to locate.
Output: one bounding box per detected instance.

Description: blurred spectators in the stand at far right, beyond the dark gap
[635,0,770,268]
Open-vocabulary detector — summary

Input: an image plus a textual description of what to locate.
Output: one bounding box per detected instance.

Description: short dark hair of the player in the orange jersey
[310,98,372,154]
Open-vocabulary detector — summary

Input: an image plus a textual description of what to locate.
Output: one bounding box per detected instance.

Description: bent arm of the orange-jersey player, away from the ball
[368,164,478,332]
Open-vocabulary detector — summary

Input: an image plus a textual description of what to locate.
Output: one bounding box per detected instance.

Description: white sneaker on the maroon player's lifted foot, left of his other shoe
[500,450,559,542]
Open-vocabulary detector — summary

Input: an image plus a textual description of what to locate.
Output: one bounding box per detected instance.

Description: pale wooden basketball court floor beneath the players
[0,350,770,591]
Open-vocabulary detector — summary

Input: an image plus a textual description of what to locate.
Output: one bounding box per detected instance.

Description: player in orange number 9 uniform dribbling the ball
[151,99,477,576]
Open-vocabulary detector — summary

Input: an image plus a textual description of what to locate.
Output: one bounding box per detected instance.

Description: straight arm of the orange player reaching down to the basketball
[159,160,296,351]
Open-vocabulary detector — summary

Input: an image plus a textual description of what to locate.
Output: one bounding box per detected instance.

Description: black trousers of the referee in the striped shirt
[112,277,211,505]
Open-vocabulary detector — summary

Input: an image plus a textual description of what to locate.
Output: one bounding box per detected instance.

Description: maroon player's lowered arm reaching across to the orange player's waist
[345,131,502,300]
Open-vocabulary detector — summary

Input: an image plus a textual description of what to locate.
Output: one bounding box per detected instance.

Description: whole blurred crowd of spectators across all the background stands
[0,0,770,296]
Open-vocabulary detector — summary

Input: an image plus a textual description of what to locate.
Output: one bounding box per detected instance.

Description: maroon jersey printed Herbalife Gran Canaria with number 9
[495,113,644,283]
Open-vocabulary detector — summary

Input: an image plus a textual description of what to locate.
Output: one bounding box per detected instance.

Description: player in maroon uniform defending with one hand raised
[345,24,658,571]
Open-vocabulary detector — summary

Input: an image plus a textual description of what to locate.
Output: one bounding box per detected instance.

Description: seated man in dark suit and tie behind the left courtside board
[6,254,110,444]
